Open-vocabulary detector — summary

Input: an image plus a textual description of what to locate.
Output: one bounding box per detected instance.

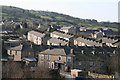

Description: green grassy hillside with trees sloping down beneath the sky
[1,6,118,30]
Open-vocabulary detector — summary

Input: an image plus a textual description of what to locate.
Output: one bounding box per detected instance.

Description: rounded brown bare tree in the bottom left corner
[2,61,23,78]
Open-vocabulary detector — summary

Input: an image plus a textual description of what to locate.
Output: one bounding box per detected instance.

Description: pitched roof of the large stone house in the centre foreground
[40,49,66,56]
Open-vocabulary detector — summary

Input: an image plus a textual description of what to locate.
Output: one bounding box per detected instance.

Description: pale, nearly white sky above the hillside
[0,0,119,22]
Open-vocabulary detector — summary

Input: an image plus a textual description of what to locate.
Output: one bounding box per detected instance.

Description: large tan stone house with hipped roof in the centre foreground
[38,48,73,70]
